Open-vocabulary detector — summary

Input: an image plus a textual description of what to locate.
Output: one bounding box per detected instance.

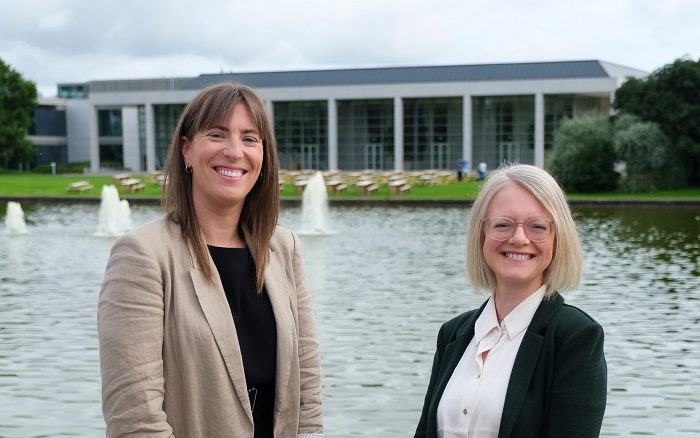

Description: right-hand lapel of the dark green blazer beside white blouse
[498,293,564,438]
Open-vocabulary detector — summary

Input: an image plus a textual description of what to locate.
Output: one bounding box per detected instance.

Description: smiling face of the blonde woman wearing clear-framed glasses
[482,183,556,295]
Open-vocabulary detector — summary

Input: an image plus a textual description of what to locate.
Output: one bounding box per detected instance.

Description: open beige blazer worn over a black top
[97,217,323,438]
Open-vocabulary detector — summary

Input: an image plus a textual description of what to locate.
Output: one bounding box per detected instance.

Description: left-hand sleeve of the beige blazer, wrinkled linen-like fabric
[97,234,173,437]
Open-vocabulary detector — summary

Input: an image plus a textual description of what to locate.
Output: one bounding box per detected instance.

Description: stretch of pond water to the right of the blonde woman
[572,209,700,437]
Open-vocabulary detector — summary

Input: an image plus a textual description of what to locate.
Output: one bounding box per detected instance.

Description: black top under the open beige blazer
[209,246,277,438]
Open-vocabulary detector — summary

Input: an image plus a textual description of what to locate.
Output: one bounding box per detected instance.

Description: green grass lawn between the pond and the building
[0,171,700,200]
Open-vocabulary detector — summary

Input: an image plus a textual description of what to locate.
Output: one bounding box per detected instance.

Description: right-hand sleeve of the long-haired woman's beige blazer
[292,233,323,436]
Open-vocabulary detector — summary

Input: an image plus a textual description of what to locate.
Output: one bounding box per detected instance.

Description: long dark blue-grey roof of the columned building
[182,60,648,89]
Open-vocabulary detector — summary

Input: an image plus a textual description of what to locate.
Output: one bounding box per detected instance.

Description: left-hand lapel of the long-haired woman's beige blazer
[190,248,253,423]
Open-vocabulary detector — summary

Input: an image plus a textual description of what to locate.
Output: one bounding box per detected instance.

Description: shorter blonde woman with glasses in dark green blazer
[415,164,607,438]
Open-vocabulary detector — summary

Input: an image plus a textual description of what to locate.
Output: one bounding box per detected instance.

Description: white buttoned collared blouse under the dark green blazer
[437,285,546,438]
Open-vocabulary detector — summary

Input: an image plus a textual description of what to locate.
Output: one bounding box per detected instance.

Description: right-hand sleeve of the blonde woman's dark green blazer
[547,319,607,438]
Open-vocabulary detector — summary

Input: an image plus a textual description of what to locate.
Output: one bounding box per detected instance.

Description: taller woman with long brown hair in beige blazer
[98,83,323,438]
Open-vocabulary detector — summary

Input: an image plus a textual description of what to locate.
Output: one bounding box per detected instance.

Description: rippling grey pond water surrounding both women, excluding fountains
[0,205,700,438]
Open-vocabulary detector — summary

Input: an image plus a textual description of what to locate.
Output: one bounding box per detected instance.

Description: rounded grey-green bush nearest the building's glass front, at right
[547,113,619,193]
